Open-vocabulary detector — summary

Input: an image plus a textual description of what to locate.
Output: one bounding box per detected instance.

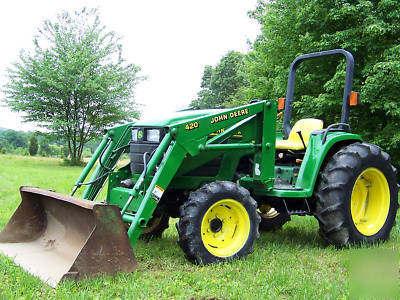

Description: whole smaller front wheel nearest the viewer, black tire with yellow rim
[176,181,260,264]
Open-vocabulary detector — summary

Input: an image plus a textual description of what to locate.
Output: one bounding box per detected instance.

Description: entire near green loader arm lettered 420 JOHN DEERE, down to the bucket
[117,101,276,247]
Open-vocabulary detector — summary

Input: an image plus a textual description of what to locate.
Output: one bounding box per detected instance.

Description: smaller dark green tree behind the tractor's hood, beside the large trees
[190,51,245,108]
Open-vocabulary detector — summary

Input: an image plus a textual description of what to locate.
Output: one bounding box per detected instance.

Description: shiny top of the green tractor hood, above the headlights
[135,109,224,127]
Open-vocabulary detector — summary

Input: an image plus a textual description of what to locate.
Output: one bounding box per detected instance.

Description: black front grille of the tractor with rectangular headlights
[130,127,165,174]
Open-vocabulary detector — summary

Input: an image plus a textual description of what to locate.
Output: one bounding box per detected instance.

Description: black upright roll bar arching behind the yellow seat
[283,49,354,138]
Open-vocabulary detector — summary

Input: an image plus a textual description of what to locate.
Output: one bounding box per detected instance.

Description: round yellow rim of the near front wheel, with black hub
[201,199,250,257]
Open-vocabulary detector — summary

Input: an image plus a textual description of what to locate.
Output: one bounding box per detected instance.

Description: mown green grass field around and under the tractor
[0,155,400,299]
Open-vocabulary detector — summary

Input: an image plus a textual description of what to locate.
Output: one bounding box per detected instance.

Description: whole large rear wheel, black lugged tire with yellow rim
[315,143,399,247]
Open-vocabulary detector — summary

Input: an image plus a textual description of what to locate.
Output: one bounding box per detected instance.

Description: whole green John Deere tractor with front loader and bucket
[0,49,398,285]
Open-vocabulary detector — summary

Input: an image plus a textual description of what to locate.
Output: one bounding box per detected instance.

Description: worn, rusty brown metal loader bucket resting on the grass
[0,187,137,287]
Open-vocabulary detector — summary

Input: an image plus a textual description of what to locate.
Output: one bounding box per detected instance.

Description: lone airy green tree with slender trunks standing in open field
[4,8,141,164]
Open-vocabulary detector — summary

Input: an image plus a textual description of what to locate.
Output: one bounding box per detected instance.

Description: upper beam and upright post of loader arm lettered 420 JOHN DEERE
[171,101,277,184]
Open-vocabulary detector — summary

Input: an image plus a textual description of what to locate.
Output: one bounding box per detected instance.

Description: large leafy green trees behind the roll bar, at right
[246,0,400,164]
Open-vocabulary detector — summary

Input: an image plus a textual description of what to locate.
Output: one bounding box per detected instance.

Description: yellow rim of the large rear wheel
[351,168,390,236]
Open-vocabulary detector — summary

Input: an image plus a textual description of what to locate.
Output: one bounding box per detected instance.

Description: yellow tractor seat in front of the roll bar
[275,119,324,150]
